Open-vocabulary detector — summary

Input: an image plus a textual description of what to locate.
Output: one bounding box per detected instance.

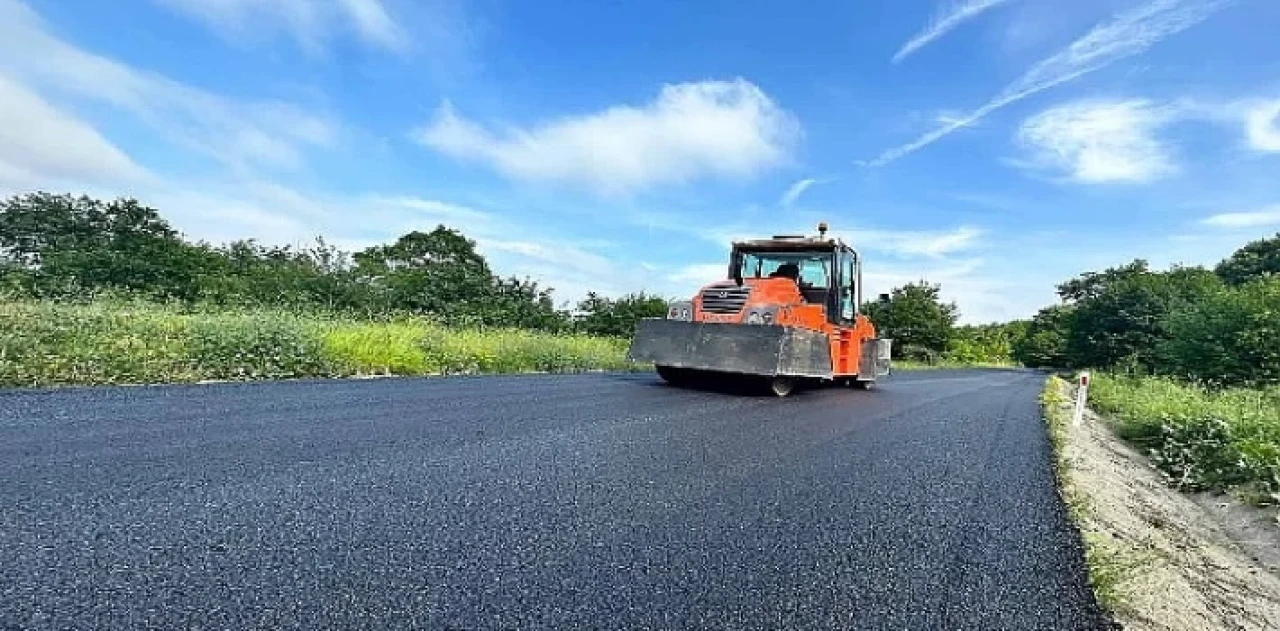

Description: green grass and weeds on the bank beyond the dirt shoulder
[1089,374,1280,504]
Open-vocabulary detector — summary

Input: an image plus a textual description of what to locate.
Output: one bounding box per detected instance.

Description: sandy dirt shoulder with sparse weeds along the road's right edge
[1050,380,1280,631]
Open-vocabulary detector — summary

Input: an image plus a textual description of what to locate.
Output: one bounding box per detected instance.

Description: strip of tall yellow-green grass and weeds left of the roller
[0,300,640,387]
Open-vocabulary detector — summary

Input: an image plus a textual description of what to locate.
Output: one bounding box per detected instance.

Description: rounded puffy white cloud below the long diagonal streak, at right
[1018,99,1175,183]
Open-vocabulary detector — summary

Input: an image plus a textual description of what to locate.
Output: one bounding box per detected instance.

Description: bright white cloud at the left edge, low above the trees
[0,74,150,187]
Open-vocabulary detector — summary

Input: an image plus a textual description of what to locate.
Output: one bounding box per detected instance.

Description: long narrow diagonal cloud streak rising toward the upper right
[864,0,1233,166]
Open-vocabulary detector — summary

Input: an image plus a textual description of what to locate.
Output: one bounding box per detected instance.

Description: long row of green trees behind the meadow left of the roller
[0,192,667,335]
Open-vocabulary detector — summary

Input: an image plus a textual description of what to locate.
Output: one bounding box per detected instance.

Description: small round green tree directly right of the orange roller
[863,280,960,358]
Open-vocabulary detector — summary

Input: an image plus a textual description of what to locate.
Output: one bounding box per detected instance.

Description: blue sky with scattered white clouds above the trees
[0,0,1280,317]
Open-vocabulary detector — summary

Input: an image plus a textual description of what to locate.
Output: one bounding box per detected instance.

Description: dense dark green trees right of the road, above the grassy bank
[1014,234,1280,387]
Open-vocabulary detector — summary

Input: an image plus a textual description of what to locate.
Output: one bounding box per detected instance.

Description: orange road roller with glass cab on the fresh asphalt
[627,224,891,395]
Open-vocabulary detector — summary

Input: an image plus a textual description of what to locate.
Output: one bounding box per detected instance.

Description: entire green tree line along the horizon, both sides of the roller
[0,192,1280,385]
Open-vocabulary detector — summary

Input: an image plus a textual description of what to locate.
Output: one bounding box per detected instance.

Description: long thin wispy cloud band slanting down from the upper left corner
[0,0,338,168]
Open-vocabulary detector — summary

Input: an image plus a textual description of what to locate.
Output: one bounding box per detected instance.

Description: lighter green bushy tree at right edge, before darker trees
[1158,276,1280,385]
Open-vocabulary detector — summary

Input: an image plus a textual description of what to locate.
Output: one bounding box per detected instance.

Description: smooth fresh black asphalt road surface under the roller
[0,370,1101,630]
